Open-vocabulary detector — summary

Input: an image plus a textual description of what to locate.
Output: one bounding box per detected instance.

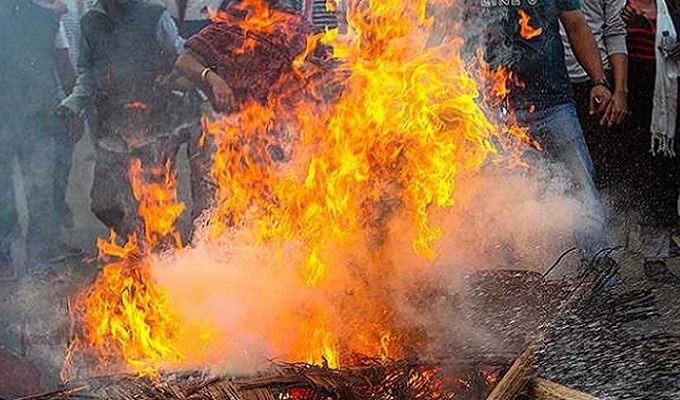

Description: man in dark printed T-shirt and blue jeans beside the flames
[463,0,613,265]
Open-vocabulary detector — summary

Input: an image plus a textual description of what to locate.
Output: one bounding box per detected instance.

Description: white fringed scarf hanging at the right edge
[650,0,678,157]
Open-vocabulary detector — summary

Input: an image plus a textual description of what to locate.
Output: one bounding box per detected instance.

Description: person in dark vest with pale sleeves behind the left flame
[59,0,195,242]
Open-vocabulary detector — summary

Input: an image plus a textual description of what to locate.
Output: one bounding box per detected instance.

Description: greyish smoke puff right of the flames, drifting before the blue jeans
[391,156,587,357]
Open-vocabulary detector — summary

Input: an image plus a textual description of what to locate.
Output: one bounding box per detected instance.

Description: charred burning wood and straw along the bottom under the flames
[24,362,500,400]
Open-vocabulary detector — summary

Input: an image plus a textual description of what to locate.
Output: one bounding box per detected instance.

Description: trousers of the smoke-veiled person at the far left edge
[0,115,66,262]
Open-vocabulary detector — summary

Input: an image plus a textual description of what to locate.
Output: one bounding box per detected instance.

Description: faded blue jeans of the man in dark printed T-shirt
[517,103,609,258]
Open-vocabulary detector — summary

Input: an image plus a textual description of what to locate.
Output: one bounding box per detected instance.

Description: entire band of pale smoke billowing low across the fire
[154,152,585,374]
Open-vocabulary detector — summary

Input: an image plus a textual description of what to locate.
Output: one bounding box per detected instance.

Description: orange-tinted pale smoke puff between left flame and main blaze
[154,237,332,374]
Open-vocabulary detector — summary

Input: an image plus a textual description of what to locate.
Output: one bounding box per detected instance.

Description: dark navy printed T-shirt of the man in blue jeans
[476,0,580,109]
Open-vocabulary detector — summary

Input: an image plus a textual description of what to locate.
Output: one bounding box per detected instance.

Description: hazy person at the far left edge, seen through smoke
[0,0,76,278]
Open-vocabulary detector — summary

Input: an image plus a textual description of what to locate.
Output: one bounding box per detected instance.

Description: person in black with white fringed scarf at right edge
[615,0,680,284]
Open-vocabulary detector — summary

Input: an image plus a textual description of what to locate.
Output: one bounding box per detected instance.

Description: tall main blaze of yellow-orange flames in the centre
[199,1,524,365]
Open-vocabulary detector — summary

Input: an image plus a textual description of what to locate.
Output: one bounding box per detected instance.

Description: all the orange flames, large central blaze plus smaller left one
[71,0,523,373]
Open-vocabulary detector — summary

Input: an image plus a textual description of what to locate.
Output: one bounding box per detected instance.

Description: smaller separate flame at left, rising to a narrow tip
[67,159,199,374]
